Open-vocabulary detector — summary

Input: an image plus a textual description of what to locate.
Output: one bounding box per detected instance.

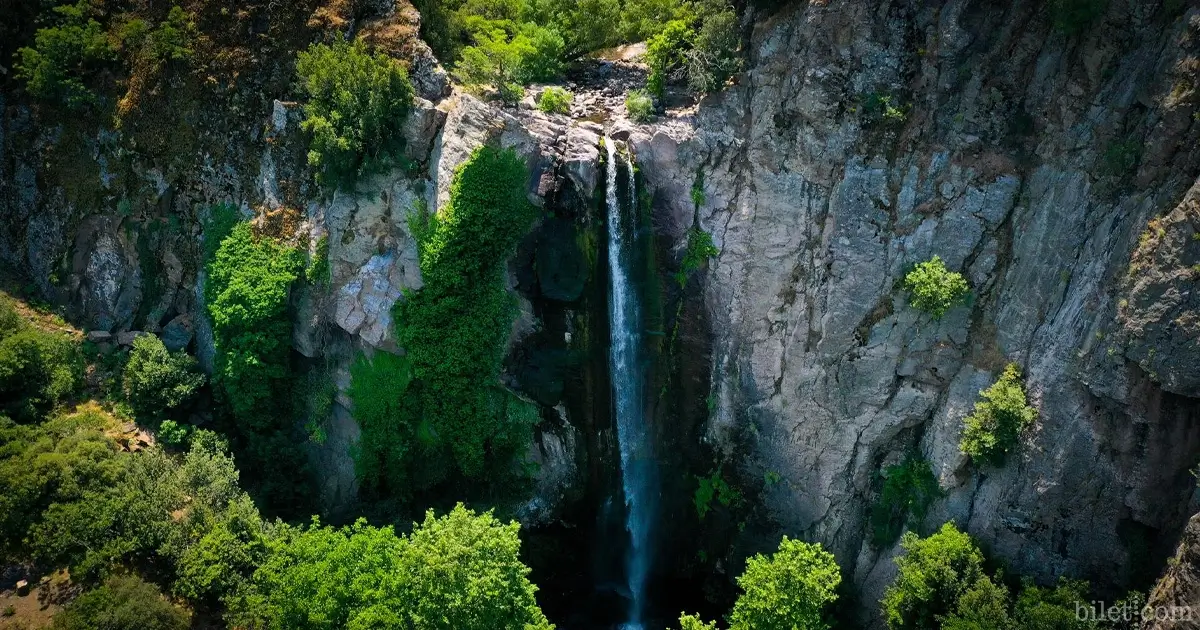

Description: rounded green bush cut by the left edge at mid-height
[0,294,83,421]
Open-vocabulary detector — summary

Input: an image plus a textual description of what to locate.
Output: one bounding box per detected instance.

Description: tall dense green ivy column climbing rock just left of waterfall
[350,146,538,492]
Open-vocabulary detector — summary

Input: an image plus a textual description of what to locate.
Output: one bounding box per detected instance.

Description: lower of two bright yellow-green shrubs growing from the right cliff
[959,364,1038,466]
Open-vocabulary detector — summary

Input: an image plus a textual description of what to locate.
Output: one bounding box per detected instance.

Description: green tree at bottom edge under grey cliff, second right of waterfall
[882,523,988,630]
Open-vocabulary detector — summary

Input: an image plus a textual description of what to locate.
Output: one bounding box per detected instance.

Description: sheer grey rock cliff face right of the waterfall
[631,0,1200,617]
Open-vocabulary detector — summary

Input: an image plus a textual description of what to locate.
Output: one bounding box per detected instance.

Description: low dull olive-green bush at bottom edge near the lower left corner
[53,576,191,630]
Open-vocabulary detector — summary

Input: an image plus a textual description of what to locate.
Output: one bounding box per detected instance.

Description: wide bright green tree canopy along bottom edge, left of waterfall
[234,505,553,630]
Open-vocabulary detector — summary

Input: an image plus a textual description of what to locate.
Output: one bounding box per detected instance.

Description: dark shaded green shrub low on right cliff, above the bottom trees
[871,455,941,547]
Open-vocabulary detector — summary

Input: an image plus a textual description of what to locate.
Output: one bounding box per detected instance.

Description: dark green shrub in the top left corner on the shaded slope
[14,0,115,108]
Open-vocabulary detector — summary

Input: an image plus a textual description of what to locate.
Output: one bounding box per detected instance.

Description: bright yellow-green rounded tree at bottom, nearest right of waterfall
[730,536,841,630]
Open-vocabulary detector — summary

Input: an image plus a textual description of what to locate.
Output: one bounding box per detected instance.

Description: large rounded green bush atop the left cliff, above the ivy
[296,41,413,185]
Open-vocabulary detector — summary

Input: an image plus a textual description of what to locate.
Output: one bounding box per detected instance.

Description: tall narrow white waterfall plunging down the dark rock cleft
[604,137,658,630]
